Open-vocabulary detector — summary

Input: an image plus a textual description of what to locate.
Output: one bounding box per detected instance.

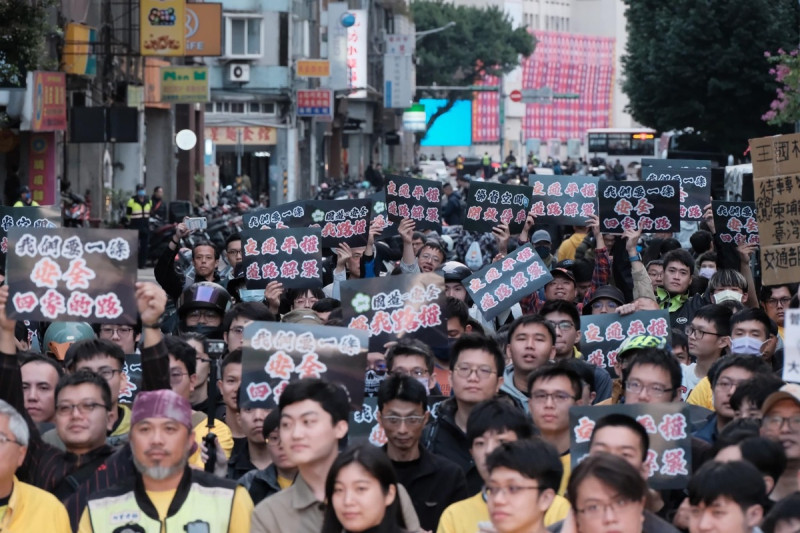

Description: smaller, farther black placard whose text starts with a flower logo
[306,198,372,248]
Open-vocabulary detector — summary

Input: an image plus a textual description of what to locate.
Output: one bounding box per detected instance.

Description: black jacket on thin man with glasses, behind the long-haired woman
[384,446,467,531]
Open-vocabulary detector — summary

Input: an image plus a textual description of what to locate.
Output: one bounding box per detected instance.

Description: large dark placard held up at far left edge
[6,227,139,324]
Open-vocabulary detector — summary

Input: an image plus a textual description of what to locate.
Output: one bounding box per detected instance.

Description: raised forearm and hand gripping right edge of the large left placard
[136,282,170,390]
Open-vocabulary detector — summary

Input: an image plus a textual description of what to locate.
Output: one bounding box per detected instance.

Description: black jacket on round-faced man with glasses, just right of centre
[422,398,483,494]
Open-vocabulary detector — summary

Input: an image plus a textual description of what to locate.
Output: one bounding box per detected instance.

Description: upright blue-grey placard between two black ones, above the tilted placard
[528,174,599,226]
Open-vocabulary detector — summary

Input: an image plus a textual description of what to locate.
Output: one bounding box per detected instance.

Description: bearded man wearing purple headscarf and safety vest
[78,390,253,533]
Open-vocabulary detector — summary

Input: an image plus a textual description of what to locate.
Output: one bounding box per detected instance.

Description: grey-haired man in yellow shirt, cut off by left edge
[0,400,72,533]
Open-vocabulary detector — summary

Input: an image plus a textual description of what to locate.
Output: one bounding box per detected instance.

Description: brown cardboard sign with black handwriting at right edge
[750,133,800,285]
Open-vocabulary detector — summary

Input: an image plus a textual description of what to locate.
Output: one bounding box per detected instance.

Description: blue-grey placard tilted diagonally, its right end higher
[461,244,553,319]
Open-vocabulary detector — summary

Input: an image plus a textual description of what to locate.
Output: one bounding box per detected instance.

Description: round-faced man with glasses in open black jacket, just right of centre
[422,333,504,494]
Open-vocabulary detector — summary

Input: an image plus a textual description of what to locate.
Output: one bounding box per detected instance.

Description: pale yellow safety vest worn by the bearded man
[88,471,236,533]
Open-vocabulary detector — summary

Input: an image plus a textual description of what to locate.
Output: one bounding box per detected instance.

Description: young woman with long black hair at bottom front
[322,444,405,533]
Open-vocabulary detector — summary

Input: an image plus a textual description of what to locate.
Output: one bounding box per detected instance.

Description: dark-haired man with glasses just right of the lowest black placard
[694,355,771,445]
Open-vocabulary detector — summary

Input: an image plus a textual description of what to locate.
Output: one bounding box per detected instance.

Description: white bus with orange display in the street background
[585,128,659,179]
